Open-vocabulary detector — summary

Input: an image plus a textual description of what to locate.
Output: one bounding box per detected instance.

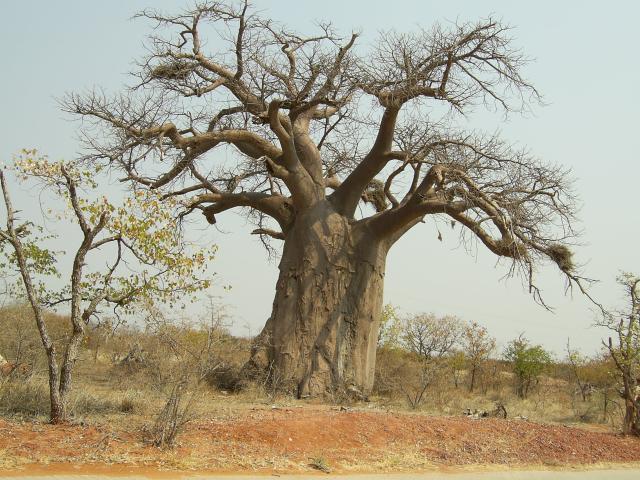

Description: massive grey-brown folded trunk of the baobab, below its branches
[251,200,389,397]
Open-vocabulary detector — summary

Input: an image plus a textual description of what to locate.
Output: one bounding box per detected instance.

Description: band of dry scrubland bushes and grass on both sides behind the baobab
[0,304,624,436]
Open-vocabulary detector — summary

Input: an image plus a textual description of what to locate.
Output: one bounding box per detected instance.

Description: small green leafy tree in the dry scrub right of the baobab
[504,334,551,398]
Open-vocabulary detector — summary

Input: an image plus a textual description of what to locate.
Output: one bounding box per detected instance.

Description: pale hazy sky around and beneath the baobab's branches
[0,0,640,354]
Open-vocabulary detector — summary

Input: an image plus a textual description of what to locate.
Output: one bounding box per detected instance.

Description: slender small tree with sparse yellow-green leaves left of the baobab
[0,150,215,423]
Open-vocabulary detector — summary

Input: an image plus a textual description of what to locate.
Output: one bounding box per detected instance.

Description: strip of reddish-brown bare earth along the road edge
[0,407,640,473]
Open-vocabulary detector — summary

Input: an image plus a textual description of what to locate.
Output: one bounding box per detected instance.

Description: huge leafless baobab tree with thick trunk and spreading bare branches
[63,2,580,397]
